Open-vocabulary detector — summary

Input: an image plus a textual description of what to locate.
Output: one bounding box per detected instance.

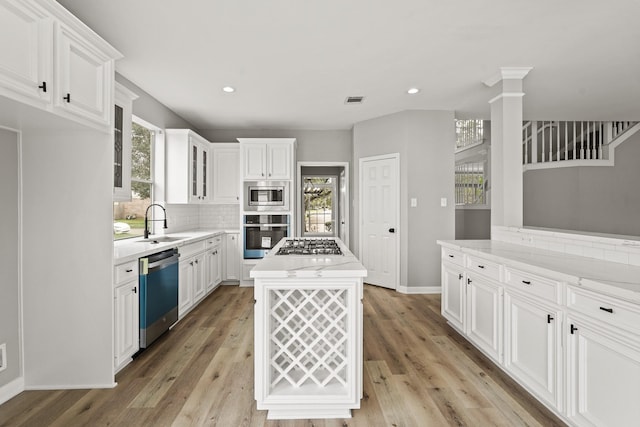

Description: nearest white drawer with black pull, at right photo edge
[567,286,640,333]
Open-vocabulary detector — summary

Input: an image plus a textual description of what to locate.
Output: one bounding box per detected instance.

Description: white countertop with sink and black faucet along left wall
[113,230,239,265]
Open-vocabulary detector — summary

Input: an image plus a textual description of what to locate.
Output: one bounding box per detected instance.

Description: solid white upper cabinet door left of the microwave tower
[211,147,240,204]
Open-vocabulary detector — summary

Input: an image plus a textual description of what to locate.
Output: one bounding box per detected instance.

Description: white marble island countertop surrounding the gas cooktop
[250,238,367,278]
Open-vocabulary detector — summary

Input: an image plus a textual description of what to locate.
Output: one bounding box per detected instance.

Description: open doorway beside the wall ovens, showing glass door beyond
[296,162,349,247]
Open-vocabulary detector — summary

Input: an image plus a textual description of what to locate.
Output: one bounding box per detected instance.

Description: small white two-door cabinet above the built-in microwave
[238,138,295,181]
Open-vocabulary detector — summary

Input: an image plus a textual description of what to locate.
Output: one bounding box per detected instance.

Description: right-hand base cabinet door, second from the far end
[466,273,502,362]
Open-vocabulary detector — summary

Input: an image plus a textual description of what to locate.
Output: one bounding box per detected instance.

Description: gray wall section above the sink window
[116,73,199,133]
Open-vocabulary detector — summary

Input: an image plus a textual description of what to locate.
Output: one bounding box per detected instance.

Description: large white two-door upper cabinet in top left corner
[0,0,122,132]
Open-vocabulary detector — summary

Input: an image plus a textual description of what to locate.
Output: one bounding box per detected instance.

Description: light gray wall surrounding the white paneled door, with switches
[352,110,455,287]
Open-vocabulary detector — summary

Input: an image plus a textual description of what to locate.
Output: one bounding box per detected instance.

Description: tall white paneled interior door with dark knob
[360,154,400,289]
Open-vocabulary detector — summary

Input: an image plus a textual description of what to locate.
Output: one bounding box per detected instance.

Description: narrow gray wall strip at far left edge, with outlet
[0,129,22,387]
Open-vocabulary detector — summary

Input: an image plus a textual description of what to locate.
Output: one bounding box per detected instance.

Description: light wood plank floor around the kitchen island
[0,286,563,427]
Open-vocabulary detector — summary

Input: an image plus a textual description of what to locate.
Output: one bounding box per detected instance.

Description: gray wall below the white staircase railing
[523,132,640,236]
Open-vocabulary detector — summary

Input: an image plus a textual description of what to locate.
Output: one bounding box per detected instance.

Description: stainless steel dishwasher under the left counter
[138,248,179,348]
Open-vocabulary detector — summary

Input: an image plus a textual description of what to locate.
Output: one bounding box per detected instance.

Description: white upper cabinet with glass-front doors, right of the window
[166,129,211,203]
